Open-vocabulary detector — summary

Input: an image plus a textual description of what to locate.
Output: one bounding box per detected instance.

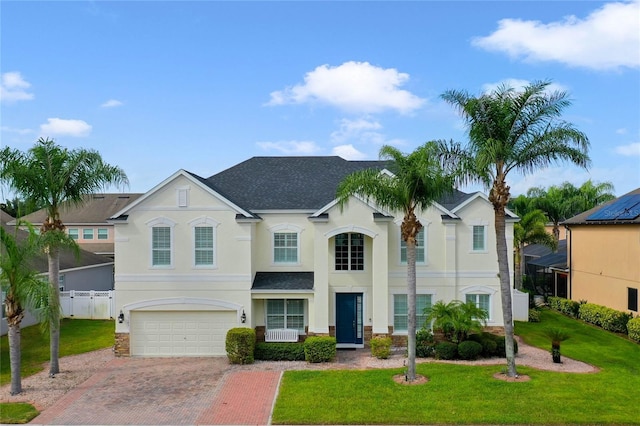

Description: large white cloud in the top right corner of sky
[472,0,640,70]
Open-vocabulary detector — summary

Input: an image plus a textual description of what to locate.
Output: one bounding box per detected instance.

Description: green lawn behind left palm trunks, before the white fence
[0,318,115,385]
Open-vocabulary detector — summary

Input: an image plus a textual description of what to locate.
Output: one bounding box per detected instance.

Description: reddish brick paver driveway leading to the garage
[31,357,282,425]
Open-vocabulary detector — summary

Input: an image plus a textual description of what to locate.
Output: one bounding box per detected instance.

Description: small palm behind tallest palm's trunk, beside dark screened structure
[513,209,558,290]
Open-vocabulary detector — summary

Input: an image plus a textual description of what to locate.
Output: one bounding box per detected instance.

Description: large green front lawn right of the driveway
[273,310,640,425]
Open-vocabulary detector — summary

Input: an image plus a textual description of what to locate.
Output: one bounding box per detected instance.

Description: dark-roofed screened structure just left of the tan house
[523,240,569,298]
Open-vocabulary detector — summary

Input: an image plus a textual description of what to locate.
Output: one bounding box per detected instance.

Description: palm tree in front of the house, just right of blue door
[337,142,453,381]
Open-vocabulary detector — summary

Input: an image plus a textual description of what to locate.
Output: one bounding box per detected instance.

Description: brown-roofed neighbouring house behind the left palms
[13,194,142,259]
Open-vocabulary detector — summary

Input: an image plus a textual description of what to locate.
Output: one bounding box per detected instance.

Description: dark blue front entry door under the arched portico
[336,293,363,347]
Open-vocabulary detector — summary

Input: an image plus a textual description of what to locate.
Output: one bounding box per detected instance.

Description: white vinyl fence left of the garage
[60,290,116,319]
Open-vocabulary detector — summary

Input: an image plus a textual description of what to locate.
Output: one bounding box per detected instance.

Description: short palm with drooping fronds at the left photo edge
[0,222,50,395]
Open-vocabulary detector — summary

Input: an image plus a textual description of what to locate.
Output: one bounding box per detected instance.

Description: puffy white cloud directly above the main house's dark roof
[267,61,425,113]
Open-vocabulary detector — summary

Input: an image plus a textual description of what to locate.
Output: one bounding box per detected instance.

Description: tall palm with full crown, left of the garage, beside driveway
[0,138,129,376]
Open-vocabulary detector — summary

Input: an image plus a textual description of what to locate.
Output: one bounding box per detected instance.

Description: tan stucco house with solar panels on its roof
[563,188,640,315]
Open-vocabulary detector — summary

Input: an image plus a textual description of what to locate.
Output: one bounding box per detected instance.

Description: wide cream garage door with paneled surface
[130,311,237,356]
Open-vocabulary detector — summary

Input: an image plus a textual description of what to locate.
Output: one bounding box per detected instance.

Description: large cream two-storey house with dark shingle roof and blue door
[112,157,517,356]
